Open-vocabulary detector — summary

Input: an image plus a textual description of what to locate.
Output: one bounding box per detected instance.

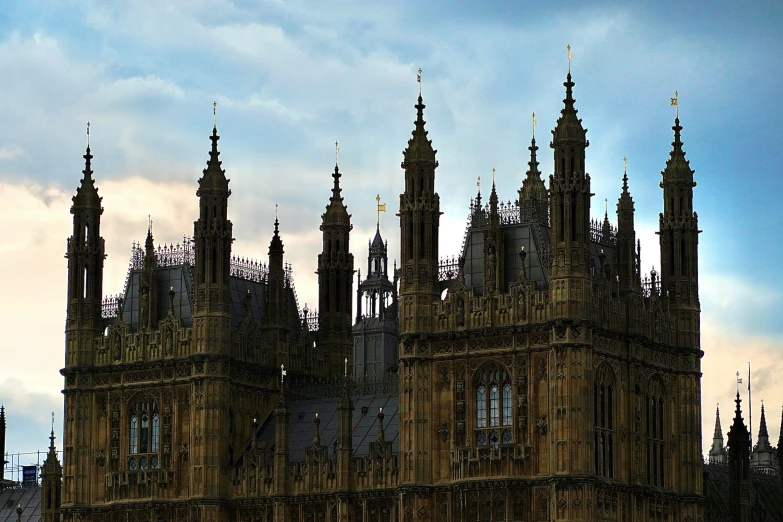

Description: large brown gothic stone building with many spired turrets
[62,73,704,522]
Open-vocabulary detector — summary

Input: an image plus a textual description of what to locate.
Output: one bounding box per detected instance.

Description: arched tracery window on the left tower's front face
[128,397,160,471]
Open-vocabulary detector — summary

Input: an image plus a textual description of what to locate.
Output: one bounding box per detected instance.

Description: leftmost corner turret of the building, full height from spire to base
[61,129,106,505]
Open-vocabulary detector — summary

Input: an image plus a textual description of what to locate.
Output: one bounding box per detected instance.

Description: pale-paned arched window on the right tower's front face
[475,364,514,448]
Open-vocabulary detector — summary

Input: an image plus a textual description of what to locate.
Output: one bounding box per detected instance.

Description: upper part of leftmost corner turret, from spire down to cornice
[65,124,106,366]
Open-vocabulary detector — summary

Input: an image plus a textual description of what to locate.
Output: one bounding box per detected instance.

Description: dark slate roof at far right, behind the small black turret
[704,464,783,522]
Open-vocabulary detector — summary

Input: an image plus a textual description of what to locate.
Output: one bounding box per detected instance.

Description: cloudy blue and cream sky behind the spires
[0,0,783,461]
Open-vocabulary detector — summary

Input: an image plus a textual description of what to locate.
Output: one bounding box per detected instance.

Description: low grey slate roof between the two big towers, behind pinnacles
[257,393,399,461]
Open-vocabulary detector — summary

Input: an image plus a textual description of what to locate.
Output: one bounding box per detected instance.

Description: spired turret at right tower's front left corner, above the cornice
[399,93,441,334]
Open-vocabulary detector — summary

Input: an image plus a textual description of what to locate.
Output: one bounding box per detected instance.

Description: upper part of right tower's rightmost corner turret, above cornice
[658,111,700,349]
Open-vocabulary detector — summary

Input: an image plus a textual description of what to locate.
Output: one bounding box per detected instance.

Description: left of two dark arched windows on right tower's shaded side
[593,364,616,478]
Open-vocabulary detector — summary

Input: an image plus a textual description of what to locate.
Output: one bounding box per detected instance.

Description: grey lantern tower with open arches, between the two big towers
[353,220,398,378]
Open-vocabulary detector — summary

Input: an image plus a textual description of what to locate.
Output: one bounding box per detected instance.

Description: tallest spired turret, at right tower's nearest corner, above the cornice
[549,71,592,317]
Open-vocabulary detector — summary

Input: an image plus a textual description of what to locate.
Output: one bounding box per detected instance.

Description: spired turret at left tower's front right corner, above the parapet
[193,115,234,314]
